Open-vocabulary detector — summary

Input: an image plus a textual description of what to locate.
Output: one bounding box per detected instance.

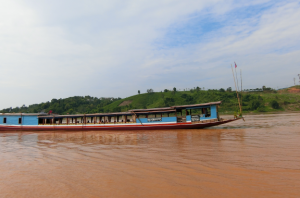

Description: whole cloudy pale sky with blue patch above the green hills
[0,0,300,109]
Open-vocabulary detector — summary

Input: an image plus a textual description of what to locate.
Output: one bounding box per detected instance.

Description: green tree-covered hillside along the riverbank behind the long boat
[0,87,300,114]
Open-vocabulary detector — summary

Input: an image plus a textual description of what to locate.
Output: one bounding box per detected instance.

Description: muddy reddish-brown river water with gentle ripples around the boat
[0,113,300,198]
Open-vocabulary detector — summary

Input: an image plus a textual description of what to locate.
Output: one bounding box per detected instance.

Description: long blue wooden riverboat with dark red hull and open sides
[0,101,240,131]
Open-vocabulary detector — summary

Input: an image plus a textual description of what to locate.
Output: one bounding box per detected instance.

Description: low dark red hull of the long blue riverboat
[0,119,239,131]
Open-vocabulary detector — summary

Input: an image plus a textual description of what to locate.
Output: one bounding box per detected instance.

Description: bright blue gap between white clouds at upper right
[154,1,276,49]
